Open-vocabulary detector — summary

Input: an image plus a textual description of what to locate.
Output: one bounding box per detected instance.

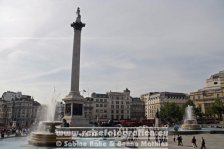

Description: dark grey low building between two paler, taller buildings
[130,97,145,120]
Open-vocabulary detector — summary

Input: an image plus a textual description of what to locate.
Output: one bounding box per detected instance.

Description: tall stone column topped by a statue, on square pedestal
[63,8,89,127]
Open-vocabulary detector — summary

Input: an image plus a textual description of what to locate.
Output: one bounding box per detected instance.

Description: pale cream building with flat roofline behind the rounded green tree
[141,92,189,119]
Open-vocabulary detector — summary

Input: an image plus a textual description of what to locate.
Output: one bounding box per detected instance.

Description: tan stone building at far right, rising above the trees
[190,71,224,113]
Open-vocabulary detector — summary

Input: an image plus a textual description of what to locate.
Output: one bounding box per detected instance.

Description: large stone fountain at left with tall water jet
[28,91,62,146]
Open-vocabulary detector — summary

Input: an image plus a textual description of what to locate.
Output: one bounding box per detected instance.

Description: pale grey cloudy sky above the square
[0,0,224,103]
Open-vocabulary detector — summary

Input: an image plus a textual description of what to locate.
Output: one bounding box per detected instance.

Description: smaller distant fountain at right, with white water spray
[181,105,201,130]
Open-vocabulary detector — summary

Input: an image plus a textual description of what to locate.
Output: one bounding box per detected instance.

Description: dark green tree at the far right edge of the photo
[211,99,224,120]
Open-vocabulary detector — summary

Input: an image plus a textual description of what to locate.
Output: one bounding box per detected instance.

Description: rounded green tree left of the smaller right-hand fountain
[159,102,183,124]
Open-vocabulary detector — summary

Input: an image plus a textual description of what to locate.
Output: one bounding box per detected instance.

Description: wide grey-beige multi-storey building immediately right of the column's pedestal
[84,89,131,122]
